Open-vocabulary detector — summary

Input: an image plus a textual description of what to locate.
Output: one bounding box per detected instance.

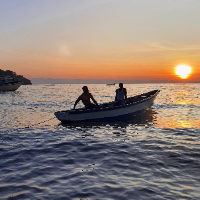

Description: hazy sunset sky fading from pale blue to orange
[0,0,200,82]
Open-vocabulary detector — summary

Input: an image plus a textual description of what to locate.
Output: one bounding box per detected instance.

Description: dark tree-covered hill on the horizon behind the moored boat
[0,69,32,85]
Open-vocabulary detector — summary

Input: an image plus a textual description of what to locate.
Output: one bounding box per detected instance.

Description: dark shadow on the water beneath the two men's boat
[58,109,157,128]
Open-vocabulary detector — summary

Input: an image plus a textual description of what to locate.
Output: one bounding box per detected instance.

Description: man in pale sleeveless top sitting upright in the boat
[114,83,127,106]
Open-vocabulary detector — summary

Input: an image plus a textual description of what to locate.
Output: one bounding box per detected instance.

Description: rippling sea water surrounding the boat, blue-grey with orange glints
[0,83,200,200]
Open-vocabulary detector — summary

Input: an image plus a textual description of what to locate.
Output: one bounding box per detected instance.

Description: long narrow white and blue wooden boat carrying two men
[54,90,160,123]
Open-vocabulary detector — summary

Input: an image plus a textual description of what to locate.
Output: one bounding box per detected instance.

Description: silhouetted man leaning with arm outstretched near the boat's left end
[74,86,99,109]
